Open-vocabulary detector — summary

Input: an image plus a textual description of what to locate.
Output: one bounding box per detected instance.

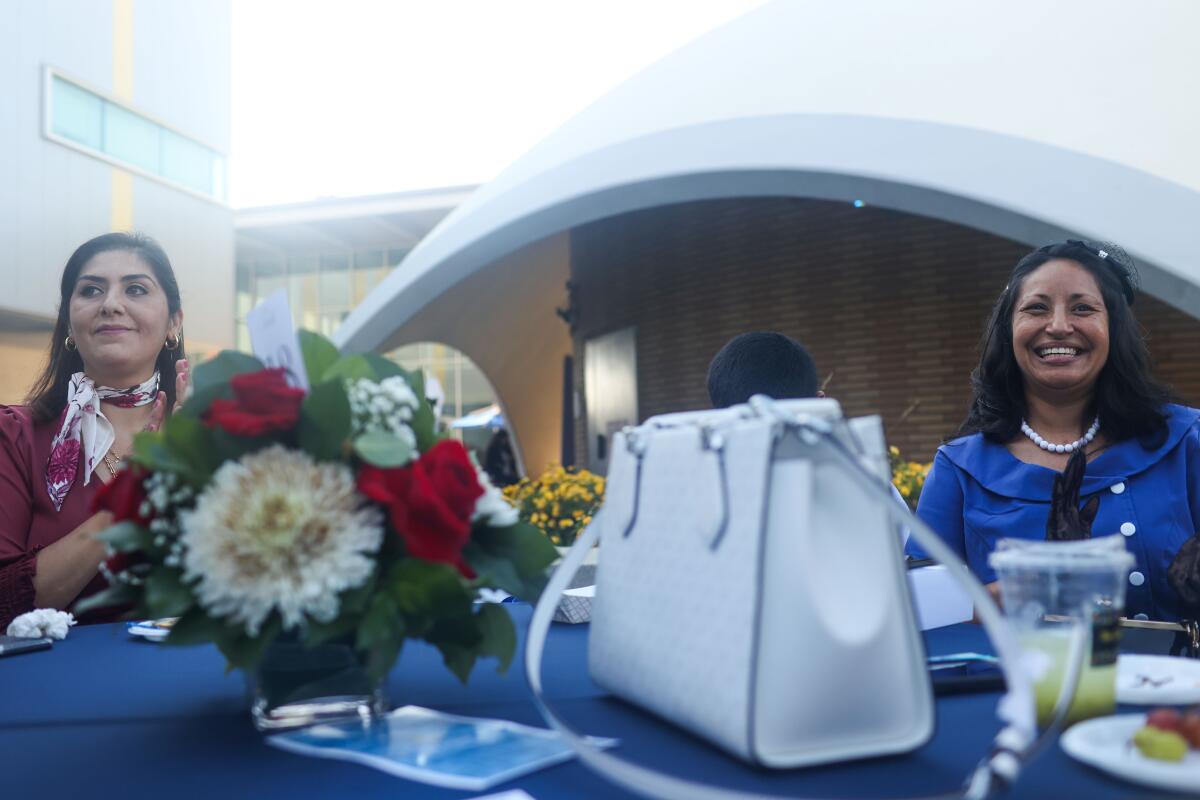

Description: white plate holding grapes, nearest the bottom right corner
[1058,714,1200,795]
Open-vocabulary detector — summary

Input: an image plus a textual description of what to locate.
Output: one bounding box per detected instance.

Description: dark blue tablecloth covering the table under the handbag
[0,604,1178,800]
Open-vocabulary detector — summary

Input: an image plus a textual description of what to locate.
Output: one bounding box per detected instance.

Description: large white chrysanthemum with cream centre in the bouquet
[180,445,383,636]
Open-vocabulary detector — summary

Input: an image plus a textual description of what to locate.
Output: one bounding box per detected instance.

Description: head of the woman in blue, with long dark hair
[960,240,1170,441]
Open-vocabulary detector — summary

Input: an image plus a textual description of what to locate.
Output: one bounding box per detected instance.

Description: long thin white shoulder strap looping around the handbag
[524,395,1086,800]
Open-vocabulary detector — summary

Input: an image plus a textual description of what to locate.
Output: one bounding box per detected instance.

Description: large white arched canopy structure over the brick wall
[336,0,1200,468]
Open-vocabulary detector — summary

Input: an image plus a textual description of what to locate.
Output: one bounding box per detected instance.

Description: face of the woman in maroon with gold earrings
[70,249,182,387]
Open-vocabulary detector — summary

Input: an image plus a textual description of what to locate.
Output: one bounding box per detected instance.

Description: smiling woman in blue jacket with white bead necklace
[910,241,1200,620]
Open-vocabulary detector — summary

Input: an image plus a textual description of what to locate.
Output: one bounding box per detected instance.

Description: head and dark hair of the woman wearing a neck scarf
[28,233,185,421]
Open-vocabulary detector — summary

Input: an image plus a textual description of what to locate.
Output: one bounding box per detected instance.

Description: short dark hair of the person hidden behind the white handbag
[708,331,817,408]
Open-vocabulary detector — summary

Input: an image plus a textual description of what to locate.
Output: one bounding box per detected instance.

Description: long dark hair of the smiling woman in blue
[956,240,1171,446]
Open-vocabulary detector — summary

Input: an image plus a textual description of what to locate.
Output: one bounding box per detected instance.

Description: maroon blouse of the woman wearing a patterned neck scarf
[0,405,112,633]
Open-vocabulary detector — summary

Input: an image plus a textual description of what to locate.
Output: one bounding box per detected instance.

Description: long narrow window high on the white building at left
[44,70,226,203]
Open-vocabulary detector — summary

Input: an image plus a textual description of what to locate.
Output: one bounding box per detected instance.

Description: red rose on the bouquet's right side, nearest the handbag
[358,441,484,578]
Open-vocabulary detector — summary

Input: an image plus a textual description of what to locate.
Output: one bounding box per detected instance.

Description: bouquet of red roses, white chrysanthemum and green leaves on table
[85,331,557,727]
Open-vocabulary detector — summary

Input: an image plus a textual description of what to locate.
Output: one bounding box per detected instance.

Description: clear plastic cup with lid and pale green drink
[988,536,1134,727]
